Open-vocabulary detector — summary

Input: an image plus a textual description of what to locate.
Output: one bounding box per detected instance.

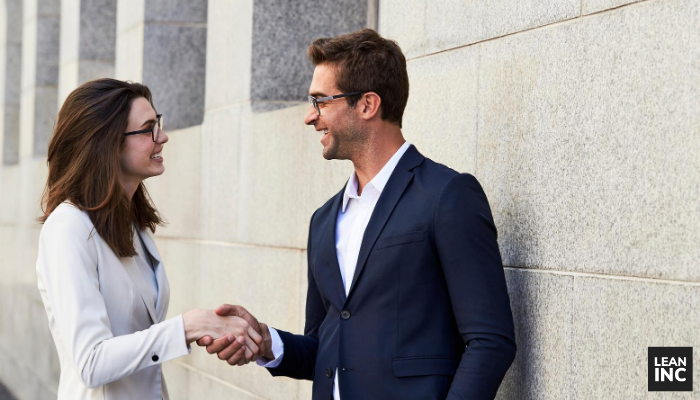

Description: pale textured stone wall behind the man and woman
[0,0,700,400]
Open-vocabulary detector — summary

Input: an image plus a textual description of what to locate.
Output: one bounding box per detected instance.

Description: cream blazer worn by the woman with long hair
[36,203,189,400]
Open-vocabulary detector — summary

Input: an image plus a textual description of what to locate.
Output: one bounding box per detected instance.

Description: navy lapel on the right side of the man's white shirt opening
[346,145,425,302]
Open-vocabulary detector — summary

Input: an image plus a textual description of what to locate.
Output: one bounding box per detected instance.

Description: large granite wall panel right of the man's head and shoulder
[476,0,700,281]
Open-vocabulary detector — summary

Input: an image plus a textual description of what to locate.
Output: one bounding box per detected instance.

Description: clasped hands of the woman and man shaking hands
[182,304,275,365]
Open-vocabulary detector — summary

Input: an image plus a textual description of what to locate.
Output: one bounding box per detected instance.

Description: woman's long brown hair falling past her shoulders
[39,79,163,257]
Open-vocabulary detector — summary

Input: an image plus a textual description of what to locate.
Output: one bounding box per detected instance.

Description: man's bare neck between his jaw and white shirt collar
[352,129,406,195]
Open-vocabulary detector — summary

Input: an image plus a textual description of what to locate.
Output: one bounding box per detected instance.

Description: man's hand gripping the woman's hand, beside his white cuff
[197,304,275,365]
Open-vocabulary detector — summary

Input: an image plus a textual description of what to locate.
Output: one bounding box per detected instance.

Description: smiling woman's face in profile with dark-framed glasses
[119,97,168,190]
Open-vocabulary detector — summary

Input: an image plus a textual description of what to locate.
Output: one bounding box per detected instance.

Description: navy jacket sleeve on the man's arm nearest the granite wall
[435,174,516,400]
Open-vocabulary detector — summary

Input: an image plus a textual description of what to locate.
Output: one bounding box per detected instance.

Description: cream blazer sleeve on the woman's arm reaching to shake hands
[37,208,189,388]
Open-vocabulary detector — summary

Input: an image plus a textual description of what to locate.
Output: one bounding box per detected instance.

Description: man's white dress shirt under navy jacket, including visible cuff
[257,142,411,400]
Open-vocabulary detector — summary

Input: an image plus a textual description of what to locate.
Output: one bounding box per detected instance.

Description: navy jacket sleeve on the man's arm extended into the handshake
[268,213,326,380]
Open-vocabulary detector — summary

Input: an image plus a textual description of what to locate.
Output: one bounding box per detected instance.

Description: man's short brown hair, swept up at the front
[308,29,408,127]
